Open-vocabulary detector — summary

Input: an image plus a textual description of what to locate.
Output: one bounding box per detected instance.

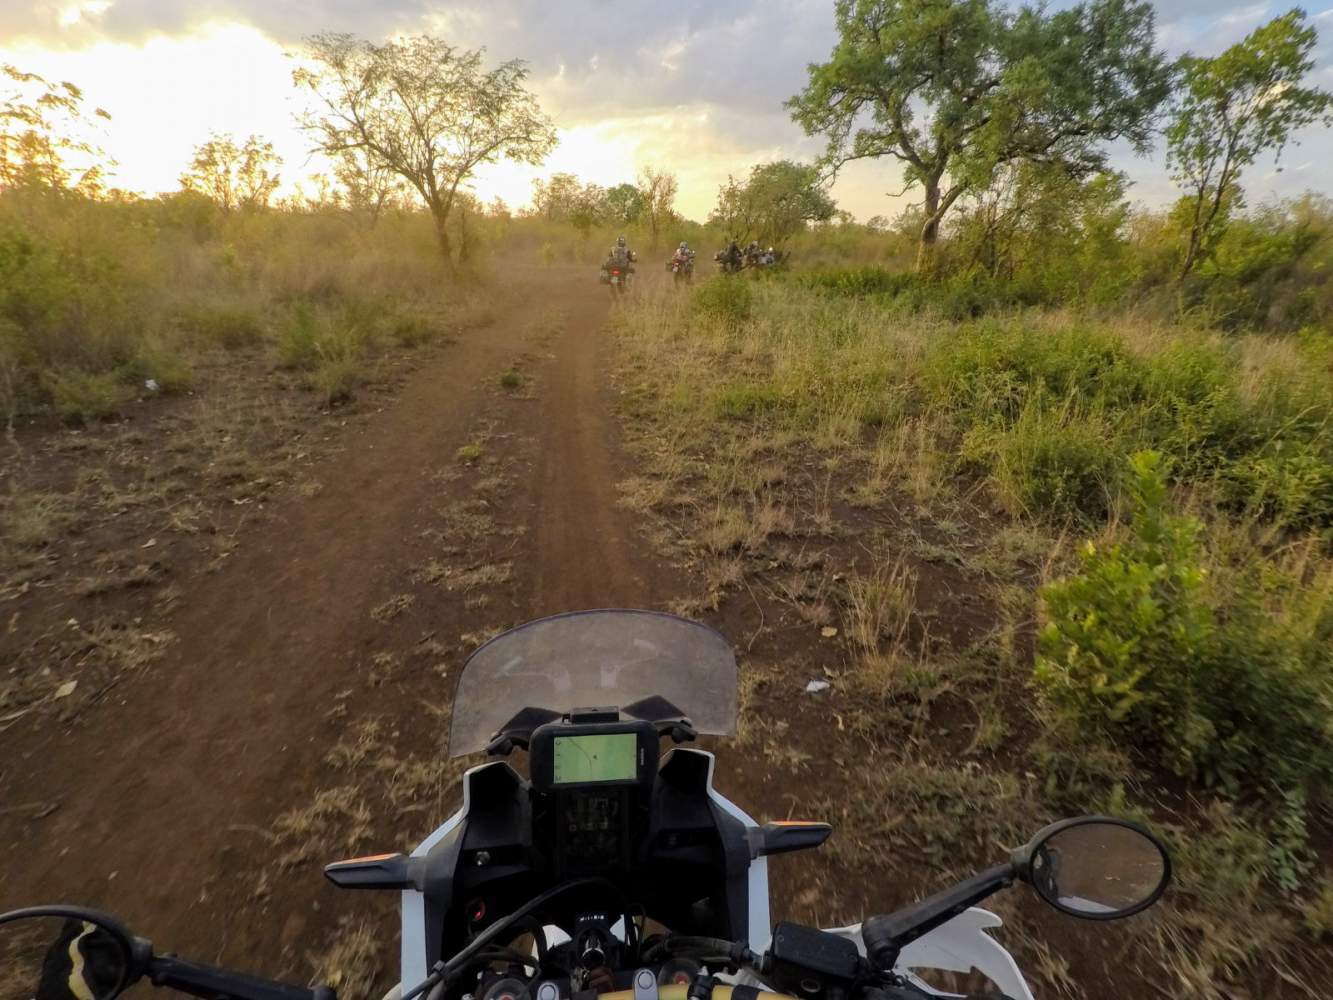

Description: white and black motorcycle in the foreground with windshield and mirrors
[0,611,1170,1000]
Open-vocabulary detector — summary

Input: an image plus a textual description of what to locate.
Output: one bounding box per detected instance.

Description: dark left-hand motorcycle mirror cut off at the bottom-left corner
[0,909,132,1000]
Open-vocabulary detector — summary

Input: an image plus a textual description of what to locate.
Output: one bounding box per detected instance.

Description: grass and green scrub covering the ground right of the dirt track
[620,256,1333,991]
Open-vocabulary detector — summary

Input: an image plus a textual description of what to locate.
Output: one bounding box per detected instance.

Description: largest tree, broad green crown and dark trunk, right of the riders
[788,0,1170,269]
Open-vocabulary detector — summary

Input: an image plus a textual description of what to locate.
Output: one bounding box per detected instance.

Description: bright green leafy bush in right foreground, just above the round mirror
[1034,452,1333,791]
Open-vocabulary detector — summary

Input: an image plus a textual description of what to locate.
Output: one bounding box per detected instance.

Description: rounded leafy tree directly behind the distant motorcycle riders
[708,160,837,245]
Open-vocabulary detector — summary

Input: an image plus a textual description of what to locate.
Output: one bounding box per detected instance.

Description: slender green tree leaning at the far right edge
[1166,9,1333,281]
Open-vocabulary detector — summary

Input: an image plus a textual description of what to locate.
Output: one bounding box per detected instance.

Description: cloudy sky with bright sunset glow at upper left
[0,0,1333,220]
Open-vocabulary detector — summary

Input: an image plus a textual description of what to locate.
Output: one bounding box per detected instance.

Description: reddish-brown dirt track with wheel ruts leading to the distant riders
[0,268,674,975]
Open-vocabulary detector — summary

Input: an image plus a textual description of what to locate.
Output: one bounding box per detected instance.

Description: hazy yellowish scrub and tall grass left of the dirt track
[0,192,493,421]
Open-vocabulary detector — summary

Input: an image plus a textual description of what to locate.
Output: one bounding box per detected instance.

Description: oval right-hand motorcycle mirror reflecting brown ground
[1028,816,1170,920]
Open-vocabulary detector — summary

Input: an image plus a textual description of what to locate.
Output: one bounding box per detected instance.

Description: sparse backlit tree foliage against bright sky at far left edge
[0,64,111,195]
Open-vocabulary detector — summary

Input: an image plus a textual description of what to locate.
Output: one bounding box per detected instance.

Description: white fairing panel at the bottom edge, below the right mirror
[829,907,1036,1000]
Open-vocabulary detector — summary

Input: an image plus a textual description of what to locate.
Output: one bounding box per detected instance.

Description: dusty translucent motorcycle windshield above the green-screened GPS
[449,611,736,757]
